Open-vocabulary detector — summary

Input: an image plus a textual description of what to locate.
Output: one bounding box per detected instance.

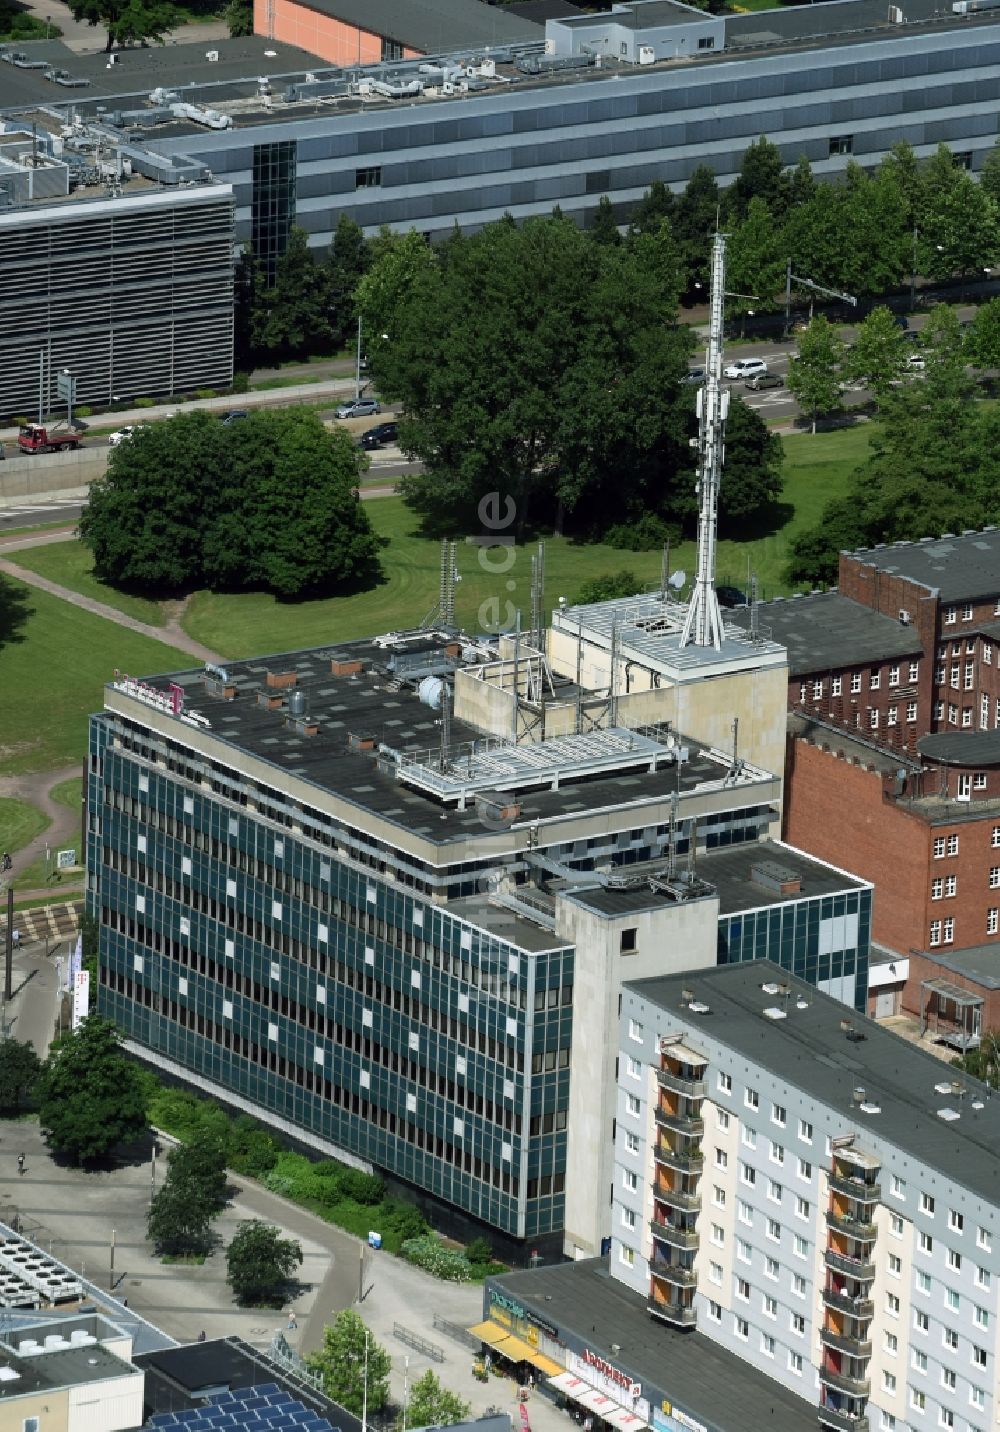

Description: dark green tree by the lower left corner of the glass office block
[36,1014,146,1163]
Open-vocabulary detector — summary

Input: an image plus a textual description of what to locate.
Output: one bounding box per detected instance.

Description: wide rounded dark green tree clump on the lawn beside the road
[80,408,380,599]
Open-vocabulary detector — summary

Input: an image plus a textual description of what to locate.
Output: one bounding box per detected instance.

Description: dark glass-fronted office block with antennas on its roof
[87,597,871,1253]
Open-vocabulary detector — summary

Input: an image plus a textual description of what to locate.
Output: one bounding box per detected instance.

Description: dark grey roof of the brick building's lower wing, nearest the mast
[728,591,923,676]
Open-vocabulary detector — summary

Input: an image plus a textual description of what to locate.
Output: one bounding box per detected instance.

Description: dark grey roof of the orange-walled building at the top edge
[283,0,544,54]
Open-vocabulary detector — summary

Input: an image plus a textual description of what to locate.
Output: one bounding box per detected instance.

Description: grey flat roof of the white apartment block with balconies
[626,954,1000,1203]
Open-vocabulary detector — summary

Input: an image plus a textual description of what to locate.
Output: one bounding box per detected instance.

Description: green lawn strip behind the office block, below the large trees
[183,424,871,657]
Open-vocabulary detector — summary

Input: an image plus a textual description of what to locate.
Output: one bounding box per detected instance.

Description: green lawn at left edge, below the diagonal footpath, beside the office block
[0,581,191,773]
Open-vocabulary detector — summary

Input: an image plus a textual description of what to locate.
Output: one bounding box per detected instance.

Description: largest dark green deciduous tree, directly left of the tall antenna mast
[360,216,691,534]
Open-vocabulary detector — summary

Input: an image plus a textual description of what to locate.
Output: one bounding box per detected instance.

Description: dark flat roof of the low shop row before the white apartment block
[490,1265,808,1432]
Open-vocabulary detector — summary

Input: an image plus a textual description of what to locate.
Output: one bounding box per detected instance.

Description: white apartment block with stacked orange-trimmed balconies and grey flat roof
[610,961,1000,1432]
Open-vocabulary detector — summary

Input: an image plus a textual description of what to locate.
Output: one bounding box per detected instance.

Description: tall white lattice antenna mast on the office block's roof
[681,233,729,650]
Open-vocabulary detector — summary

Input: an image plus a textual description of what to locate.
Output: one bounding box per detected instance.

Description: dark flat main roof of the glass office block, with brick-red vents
[107,634,774,843]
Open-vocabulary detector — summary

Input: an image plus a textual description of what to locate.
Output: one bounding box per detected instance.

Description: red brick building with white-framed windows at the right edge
[738,527,1000,1027]
